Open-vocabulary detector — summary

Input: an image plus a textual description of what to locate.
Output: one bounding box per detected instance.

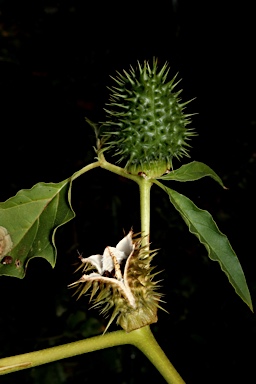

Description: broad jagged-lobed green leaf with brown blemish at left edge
[0,179,75,278]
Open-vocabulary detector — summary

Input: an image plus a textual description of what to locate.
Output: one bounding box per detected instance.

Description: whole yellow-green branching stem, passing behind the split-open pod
[0,158,184,384]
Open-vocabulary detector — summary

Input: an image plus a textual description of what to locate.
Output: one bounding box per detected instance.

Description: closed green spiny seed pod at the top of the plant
[101,59,194,177]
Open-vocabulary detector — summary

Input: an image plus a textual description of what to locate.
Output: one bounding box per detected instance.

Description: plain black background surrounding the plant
[0,0,256,384]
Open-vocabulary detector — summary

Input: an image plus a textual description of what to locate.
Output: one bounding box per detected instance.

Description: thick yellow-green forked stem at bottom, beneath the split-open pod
[0,327,184,384]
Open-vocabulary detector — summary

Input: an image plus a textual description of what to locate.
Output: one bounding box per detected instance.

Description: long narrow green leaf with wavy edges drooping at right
[164,187,253,310]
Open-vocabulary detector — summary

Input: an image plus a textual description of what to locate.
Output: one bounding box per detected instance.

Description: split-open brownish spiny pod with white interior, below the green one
[70,231,161,332]
